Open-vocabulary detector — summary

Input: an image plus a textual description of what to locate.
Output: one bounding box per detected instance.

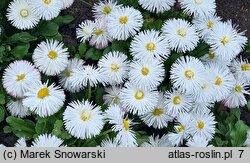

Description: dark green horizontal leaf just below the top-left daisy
[7,32,37,43]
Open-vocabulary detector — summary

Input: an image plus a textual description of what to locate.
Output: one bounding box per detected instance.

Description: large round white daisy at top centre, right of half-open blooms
[107,7,143,40]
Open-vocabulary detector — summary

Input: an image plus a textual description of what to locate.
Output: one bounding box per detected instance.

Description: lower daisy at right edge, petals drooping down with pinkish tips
[223,80,250,108]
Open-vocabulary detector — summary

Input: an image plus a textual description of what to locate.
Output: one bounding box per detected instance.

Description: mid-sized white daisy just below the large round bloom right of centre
[164,90,193,117]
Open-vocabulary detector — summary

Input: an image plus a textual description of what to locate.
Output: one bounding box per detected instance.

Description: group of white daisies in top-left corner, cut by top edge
[7,0,74,30]
